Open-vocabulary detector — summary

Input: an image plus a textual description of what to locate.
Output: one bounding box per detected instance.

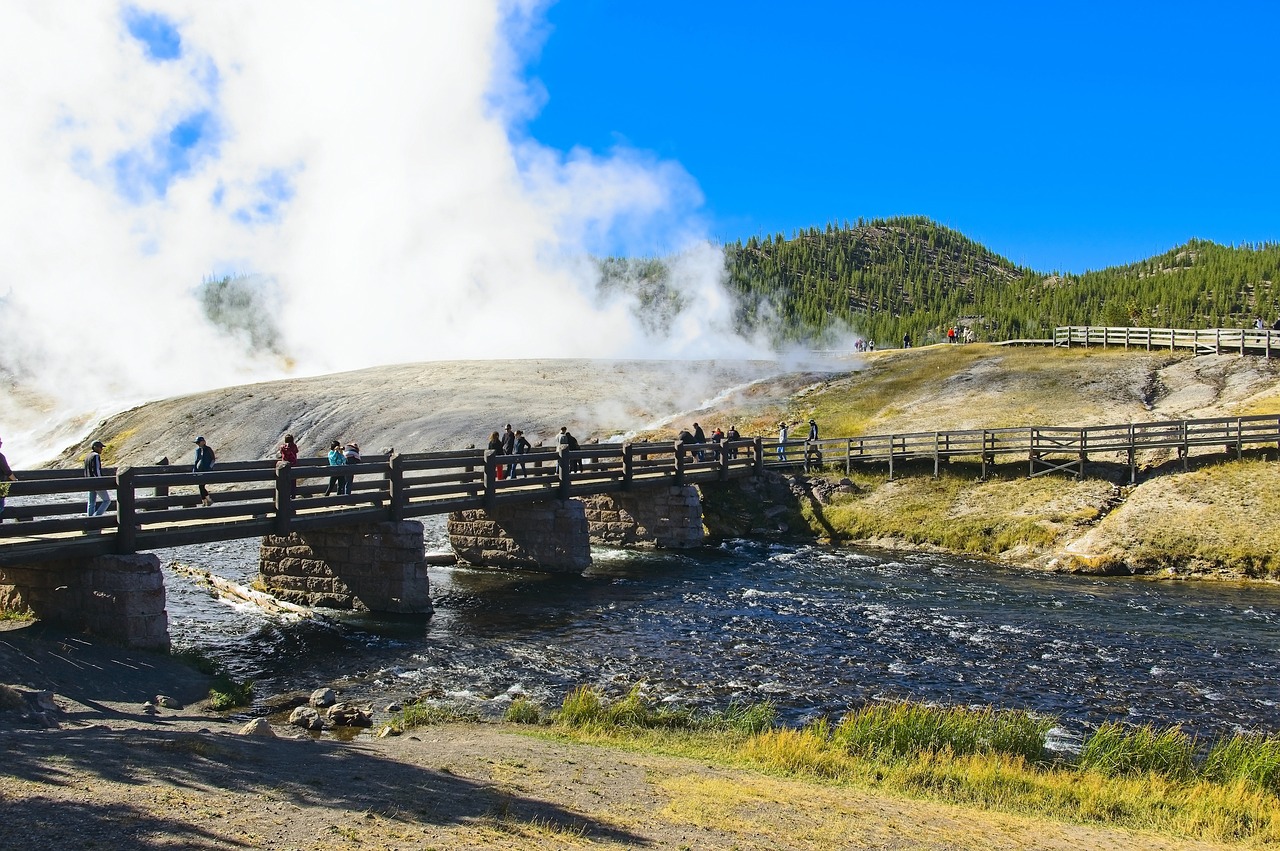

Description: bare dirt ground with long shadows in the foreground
[0,624,1239,851]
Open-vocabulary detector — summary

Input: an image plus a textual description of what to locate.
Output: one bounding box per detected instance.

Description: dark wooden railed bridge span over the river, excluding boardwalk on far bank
[0,439,763,564]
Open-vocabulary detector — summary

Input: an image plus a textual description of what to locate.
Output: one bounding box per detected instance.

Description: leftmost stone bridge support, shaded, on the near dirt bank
[0,553,169,650]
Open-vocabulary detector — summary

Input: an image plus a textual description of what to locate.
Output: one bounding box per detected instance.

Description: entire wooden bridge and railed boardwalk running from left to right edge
[0,415,1280,566]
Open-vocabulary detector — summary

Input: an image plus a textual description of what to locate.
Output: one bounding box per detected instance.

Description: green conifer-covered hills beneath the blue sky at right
[716,218,1280,346]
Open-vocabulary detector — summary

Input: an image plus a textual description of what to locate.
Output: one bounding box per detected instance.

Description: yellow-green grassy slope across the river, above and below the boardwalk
[696,346,1280,581]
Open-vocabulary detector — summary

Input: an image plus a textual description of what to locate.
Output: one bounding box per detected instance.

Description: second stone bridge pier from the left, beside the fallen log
[259,520,431,614]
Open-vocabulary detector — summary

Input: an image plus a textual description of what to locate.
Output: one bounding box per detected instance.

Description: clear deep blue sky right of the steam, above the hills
[527,0,1280,271]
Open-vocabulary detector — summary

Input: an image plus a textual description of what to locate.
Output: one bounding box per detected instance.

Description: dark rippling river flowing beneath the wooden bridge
[160,518,1280,742]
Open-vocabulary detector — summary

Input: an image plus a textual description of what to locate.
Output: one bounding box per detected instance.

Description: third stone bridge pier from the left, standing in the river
[448,499,591,573]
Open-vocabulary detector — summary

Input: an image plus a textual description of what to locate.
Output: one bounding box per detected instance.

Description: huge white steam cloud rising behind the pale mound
[0,0,764,462]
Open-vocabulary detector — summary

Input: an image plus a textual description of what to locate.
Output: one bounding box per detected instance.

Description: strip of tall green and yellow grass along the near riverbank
[381,688,1280,846]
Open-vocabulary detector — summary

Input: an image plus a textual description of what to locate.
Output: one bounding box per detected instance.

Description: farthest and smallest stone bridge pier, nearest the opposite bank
[582,485,704,549]
